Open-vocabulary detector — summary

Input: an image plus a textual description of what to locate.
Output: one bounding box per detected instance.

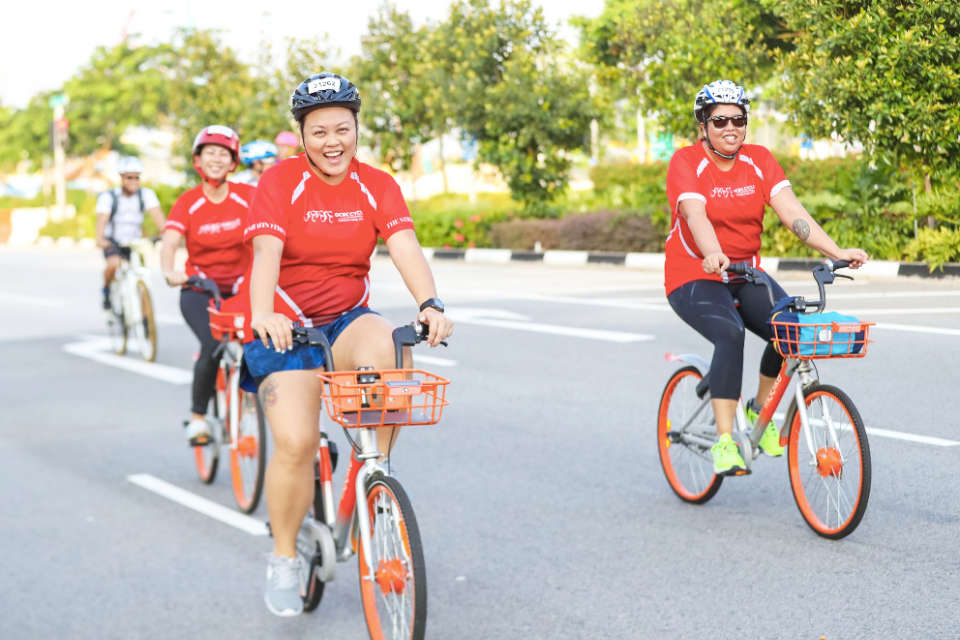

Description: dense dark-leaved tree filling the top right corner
[778,0,960,191]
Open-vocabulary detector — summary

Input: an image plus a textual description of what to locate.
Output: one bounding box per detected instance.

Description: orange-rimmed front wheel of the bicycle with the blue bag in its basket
[786,384,871,539]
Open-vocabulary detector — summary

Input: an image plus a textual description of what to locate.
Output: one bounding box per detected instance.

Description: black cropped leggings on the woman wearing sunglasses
[667,275,787,400]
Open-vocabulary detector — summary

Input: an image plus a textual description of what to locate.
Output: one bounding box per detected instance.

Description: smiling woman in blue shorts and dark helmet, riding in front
[238,73,453,616]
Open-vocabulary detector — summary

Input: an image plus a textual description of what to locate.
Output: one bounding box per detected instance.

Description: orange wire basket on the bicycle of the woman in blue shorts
[320,369,450,428]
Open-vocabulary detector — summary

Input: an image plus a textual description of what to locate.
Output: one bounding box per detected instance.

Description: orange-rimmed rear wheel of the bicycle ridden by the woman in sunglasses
[657,365,723,504]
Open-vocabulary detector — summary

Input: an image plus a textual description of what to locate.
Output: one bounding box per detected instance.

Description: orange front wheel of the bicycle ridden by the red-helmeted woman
[227,378,267,513]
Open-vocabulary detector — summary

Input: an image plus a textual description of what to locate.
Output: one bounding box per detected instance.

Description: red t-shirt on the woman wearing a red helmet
[163,182,255,291]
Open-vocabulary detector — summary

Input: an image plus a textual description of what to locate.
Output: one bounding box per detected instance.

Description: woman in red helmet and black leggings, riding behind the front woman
[160,125,254,446]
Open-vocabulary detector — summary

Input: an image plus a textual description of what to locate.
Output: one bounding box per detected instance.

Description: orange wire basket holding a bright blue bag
[770,320,876,360]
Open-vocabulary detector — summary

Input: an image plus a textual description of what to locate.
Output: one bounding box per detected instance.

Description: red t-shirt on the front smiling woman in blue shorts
[243,154,413,326]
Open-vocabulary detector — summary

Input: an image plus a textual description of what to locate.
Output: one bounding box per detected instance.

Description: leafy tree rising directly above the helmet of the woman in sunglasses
[576,0,790,135]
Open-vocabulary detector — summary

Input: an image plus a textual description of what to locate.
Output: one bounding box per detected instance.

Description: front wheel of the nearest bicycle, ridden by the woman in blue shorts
[357,473,427,640]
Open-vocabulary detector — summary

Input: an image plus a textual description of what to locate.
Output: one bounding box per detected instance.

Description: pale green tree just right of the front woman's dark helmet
[350,5,451,171]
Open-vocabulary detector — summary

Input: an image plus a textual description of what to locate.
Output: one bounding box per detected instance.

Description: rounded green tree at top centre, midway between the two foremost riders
[436,0,597,213]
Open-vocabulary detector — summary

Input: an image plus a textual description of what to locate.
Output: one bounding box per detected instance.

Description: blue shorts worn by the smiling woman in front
[240,307,376,393]
